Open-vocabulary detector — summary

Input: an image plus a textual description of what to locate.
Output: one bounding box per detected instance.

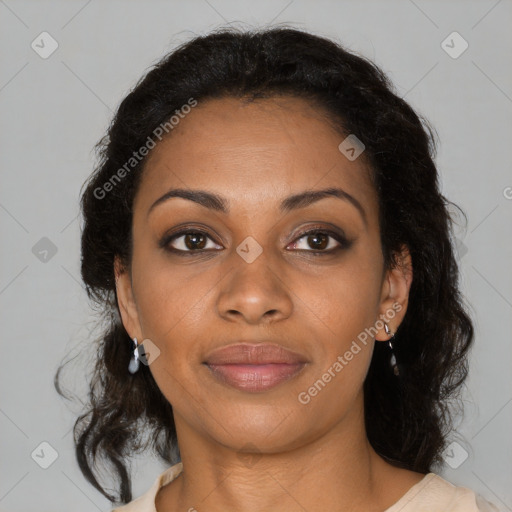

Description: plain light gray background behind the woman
[0,0,512,512]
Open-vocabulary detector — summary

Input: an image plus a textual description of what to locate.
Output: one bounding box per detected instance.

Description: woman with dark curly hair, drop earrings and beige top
[55,29,497,512]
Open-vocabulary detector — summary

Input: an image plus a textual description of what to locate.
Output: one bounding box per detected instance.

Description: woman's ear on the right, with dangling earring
[375,245,413,341]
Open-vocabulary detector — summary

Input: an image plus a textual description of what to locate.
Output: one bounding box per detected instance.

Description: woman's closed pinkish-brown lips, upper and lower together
[204,343,308,392]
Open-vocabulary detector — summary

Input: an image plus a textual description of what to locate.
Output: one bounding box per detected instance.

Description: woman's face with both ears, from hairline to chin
[116,97,410,452]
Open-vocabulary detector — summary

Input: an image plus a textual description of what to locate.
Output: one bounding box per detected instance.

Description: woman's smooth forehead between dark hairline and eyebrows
[137,97,376,218]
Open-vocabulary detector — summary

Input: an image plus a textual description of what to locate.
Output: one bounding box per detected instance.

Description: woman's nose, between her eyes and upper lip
[217,251,293,325]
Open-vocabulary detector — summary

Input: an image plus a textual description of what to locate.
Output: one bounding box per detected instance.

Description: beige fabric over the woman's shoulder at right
[385,473,501,512]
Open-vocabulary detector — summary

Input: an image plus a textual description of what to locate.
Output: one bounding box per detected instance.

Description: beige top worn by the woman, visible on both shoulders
[111,462,500,512]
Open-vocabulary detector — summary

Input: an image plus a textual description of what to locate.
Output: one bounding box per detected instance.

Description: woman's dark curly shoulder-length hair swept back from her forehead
[55,27,473,503]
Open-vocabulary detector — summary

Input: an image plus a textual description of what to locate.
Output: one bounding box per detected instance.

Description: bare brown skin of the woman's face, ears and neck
[115,97,424,512]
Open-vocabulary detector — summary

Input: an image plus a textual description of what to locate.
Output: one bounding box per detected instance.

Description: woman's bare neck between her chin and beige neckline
[157,396,423,512]
